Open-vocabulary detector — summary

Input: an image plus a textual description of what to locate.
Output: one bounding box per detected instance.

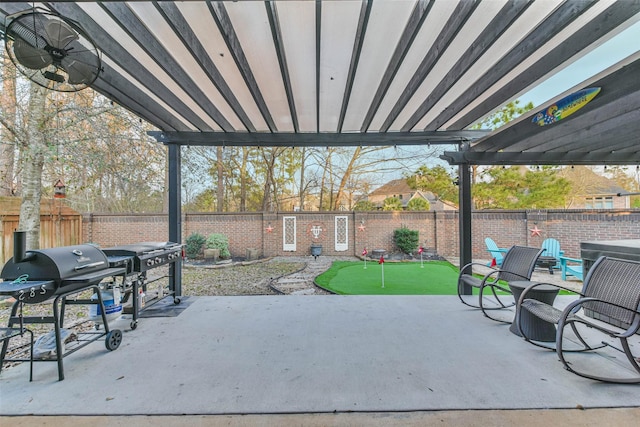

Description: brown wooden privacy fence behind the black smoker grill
[0,197,82,265]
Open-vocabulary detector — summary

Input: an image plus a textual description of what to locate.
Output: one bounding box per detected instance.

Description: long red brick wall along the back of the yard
[83,210,640,259]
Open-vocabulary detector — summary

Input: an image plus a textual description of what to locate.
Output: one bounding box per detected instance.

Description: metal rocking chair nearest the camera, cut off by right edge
[516,257,640,384]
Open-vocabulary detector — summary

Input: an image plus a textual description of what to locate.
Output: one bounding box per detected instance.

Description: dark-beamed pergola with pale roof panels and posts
[0,0,640,298]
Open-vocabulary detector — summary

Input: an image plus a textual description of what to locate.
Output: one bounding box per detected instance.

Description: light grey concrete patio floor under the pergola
[0,295,640,426]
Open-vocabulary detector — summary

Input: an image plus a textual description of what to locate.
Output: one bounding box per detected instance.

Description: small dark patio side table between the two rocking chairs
[509,280,558,342]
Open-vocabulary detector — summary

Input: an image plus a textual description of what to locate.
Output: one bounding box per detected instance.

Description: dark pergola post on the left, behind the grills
[168,144,182,296]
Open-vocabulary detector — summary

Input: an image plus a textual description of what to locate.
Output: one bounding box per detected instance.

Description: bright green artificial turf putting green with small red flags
[316,261,458,295]
